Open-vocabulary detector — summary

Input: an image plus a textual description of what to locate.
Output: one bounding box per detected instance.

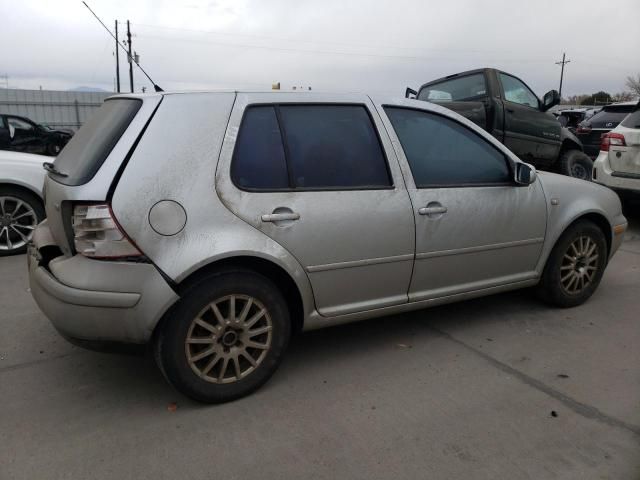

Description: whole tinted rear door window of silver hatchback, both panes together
[231,105,392,190]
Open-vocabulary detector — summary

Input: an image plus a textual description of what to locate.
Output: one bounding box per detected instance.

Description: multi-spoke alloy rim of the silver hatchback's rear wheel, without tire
[185,295,273,383]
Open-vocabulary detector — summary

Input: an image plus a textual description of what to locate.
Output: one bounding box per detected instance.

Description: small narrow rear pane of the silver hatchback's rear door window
[231,106,289,189]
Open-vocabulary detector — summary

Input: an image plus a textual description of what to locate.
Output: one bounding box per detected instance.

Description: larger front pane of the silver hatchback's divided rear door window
[280,105,391,188]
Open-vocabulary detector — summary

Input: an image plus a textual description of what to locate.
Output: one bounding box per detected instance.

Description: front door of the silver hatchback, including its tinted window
[384,107,546,301]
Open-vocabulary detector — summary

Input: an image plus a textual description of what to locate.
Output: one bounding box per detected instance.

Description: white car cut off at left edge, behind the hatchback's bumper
[0,150,51,256]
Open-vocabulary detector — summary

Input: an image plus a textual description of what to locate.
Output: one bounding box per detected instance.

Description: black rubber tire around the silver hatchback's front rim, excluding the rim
[539,220,608,307]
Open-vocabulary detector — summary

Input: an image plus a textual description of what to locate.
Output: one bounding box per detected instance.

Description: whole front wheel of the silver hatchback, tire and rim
[537,220,608,308]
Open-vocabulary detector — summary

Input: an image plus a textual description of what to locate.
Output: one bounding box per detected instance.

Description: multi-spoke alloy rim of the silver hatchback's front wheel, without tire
[560,236,600,295]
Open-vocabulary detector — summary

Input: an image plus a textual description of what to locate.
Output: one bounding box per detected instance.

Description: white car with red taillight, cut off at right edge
[593,102,640,192]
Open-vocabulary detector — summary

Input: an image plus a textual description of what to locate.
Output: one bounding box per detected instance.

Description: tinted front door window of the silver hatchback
[385,107,510,187]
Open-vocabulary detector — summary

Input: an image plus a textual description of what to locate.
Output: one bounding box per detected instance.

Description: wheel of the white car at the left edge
[0,185,45,257]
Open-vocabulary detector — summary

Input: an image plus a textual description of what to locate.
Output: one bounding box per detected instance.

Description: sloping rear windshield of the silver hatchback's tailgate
[52,98,142,185]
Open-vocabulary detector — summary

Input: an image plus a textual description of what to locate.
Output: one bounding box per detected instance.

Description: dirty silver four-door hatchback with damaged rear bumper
[28,92,626,402]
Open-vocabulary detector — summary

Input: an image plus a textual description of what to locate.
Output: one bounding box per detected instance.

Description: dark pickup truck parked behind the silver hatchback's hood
[405,68,593,180]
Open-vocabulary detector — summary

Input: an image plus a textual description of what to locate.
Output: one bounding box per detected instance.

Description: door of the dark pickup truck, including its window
[498,72,561,164]
